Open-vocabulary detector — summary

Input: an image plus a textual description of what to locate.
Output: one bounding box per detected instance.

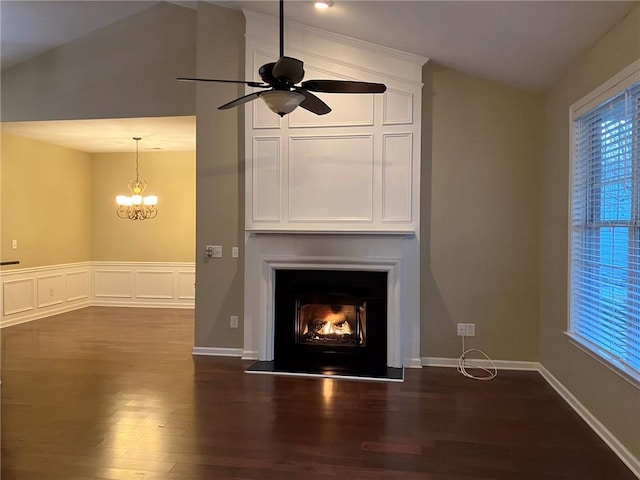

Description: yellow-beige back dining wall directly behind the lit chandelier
[91,151,195,262]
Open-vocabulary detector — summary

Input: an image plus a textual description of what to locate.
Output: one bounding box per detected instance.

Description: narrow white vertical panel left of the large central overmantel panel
[252,137,282,221]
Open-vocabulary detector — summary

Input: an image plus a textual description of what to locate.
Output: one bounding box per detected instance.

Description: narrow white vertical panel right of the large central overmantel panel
[382,133,413,222]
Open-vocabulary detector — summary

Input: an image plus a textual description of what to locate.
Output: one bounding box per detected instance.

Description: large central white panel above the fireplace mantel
[289,135,373,222]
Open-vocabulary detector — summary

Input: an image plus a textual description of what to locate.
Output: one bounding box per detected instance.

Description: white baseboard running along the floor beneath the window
[539,365,640,478]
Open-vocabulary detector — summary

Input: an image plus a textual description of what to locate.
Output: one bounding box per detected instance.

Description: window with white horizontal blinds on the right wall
[568,62,640,381]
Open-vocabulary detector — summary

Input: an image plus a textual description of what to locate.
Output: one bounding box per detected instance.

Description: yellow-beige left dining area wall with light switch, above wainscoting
[0,133,91,269]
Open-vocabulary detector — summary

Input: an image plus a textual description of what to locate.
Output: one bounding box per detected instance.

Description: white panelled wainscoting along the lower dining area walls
[0,262,195,328]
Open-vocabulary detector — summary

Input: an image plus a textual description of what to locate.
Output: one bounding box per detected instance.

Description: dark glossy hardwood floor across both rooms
[1,307,635,480]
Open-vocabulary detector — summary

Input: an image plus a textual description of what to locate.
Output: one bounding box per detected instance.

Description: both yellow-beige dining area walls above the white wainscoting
[0,133,195,268]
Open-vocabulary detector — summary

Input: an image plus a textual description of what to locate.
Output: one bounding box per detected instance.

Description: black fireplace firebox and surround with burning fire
[274,270,387,373]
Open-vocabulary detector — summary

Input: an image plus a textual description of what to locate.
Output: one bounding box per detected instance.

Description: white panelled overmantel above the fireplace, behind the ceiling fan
[244,11,428,234]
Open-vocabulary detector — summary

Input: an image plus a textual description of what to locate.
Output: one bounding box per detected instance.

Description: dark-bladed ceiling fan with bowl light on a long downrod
[178,0,387,117]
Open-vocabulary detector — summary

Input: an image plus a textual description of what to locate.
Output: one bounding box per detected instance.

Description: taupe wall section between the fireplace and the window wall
[421,63,542,361]
